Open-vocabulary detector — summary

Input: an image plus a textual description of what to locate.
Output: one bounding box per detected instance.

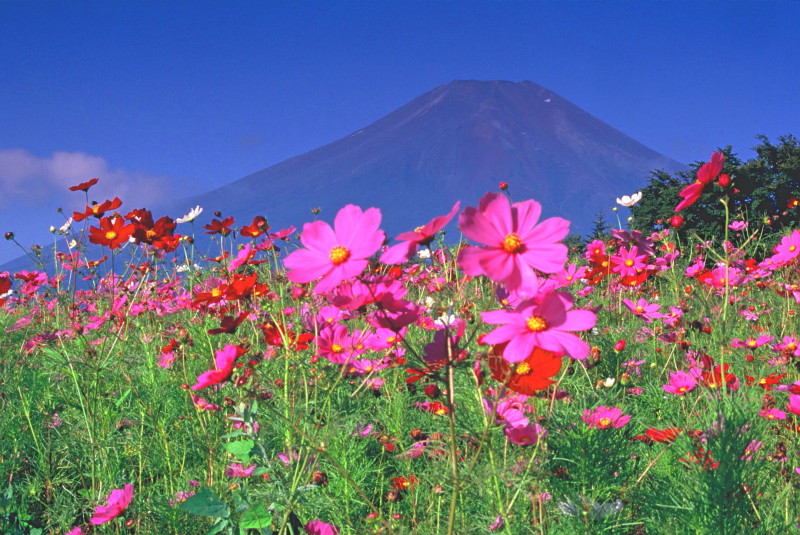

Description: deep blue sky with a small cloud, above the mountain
[0,0,800,262]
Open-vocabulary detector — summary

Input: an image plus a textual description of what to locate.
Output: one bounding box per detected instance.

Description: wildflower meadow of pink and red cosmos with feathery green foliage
[0,152,800,535]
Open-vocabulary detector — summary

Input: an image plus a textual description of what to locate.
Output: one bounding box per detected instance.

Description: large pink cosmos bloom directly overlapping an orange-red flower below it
[481,292,597,362]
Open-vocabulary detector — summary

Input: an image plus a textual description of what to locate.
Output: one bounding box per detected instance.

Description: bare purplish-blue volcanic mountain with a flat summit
[176,80,684,245]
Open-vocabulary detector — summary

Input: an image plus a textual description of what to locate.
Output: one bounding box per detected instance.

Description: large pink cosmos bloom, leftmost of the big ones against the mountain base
[283,204,385,293]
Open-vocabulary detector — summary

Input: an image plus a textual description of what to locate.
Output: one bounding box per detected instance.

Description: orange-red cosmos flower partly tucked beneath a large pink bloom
[489,343,562,396]
